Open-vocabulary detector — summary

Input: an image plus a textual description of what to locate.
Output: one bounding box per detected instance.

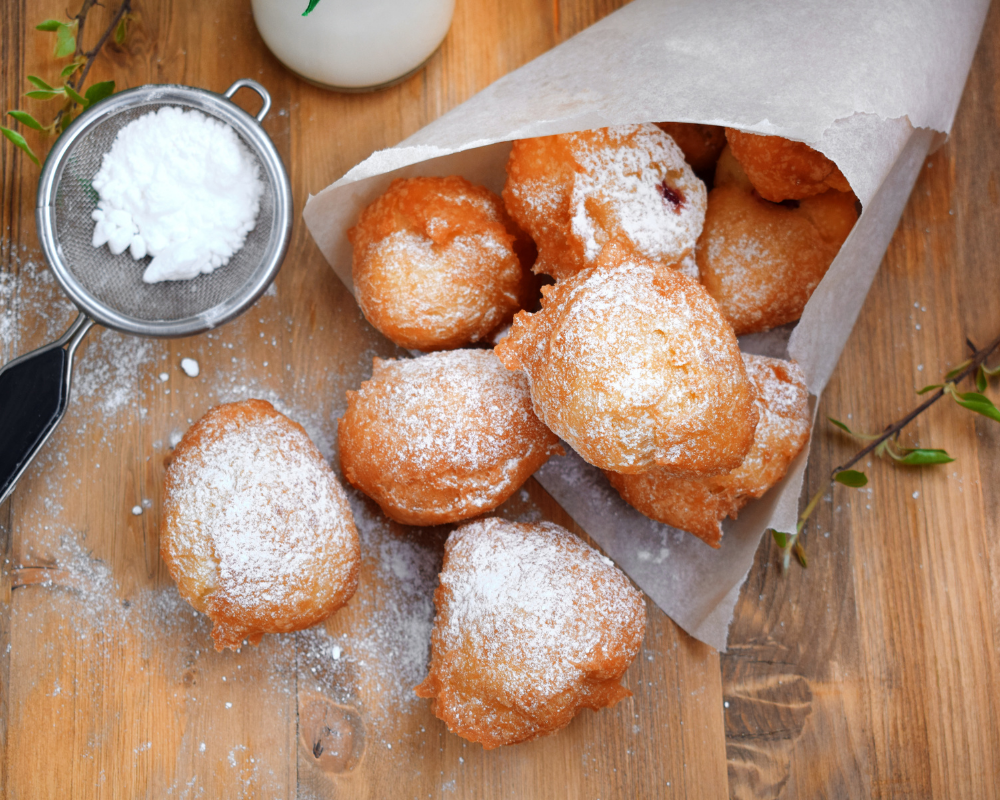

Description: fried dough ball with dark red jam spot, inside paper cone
[503,124,706,280]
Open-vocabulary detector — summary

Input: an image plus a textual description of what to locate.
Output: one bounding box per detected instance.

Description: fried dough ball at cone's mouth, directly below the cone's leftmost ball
[338,350,563,525]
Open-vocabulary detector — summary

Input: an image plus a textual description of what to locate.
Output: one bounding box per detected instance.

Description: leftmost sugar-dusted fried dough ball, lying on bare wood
[160,400,361,650]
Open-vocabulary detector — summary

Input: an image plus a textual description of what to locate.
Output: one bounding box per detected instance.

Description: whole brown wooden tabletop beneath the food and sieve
[0,0,1000,798]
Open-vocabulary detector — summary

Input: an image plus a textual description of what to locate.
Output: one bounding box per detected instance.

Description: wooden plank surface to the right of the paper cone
[722,7,1000,798]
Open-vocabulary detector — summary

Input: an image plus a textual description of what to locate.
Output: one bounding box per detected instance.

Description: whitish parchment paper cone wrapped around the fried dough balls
[304,0,988,650]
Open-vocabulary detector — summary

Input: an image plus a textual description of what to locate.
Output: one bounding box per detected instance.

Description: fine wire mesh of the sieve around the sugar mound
[53,98,275,322]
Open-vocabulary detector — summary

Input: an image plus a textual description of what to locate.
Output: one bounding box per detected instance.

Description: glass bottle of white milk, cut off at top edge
[252,0,455,91]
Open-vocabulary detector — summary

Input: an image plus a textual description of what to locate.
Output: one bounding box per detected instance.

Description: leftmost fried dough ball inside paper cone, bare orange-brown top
[347,175,537,350]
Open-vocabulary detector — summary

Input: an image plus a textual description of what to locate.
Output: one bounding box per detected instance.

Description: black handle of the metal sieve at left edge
[0,314,94,503]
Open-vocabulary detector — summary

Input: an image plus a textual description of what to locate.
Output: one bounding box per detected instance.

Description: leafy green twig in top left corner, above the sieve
[0,0,134,164]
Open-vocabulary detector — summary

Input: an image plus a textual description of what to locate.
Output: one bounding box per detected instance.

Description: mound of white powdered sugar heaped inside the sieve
[92,106,264,283]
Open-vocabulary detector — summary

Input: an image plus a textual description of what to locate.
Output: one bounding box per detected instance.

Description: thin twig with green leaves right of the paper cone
[771,328,1000,570]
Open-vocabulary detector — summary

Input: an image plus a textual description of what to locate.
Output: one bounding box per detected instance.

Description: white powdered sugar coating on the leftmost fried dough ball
[165,400,356,618]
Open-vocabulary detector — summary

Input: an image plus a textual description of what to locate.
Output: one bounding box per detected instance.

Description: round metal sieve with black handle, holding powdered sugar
[0,79,292,503]
